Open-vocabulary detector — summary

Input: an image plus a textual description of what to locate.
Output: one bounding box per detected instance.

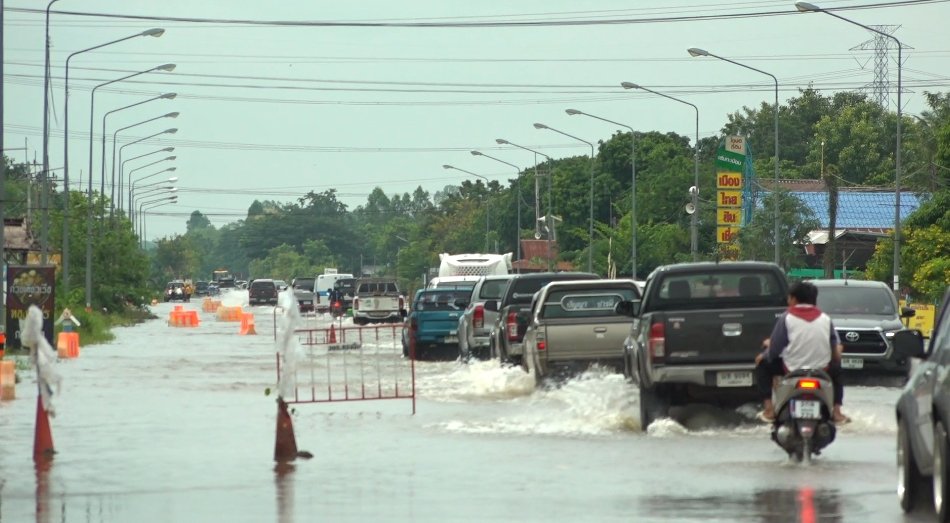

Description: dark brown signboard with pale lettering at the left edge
[6,265,56,348]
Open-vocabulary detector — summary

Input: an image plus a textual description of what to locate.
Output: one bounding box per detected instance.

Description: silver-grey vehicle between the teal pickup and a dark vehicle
[458,274,513,361]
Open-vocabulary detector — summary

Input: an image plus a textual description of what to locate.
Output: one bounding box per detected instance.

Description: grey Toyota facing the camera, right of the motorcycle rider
[812,280,915,376]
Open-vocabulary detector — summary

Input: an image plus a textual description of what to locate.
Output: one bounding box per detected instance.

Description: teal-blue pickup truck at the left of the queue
[402,289,471,359]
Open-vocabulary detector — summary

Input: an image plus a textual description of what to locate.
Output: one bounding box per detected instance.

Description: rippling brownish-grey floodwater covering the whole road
[0,291,932,523]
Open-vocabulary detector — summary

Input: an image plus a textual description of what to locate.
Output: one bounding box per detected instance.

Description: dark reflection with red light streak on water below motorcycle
[642,486,844,523]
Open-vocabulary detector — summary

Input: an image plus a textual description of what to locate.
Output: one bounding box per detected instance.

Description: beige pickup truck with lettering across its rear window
[523,280,640,386]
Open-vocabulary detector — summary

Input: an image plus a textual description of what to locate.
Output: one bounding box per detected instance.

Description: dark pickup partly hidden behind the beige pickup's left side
[484,272,600,365]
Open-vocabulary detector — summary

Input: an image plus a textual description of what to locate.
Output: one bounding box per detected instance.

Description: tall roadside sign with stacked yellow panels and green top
[716,136,746,260]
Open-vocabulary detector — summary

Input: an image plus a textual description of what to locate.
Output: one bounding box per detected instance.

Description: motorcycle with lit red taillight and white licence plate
[772,369,836,463]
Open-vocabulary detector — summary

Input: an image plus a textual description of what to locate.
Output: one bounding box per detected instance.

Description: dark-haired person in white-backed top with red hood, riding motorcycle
[755,281,850,423]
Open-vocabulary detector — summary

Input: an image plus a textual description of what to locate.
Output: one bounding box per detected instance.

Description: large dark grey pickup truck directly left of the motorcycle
[617,262,788,429]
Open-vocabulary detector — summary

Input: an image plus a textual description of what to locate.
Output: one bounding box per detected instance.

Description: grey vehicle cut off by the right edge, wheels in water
[892,287,950,521]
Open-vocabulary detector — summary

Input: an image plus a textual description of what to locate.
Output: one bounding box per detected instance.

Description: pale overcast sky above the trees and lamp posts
[3,0,950,238]
